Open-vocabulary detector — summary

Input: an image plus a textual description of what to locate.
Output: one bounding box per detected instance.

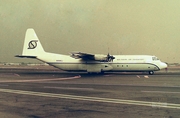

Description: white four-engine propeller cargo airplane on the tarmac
[15,28,167,75]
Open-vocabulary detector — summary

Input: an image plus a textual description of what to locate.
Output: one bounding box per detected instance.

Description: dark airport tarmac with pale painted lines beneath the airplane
[0,66,180,118]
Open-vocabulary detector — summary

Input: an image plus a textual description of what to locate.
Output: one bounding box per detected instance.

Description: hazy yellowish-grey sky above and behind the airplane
[0,0,180,62]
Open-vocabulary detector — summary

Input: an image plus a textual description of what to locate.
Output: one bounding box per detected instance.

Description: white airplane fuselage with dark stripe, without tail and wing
[37,53,167,72]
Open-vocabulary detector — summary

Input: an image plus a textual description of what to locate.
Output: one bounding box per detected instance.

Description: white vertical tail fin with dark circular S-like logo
[22,29,45,58]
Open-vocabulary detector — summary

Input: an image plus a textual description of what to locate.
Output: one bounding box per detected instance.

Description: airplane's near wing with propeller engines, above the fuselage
[71,52,115,62]
